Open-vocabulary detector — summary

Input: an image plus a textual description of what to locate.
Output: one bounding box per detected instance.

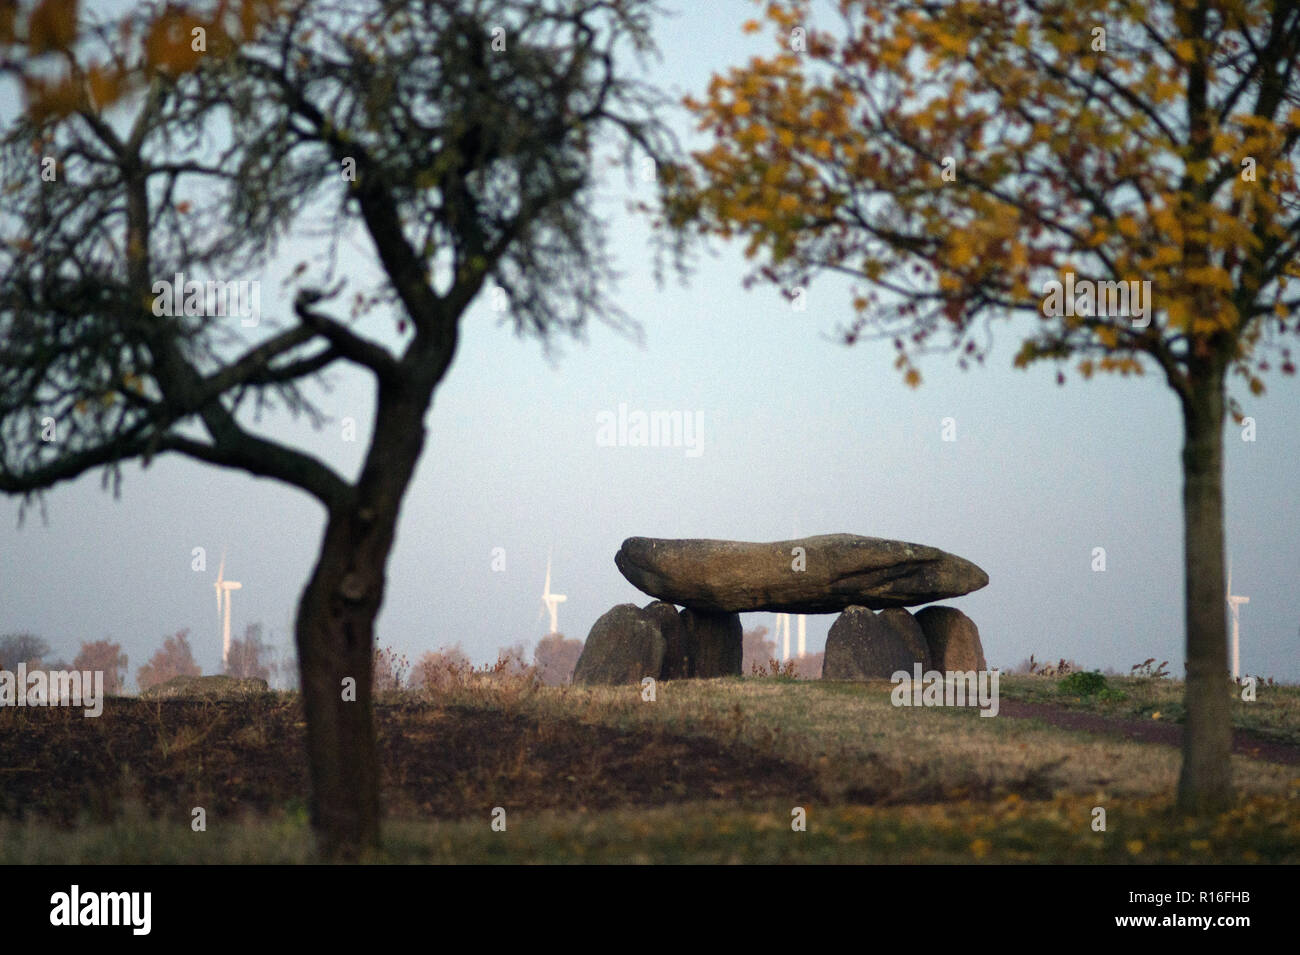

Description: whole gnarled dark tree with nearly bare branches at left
[0,0,671,856]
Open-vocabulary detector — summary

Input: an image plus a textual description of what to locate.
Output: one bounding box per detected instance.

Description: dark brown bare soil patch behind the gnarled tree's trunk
[0,698,816,825]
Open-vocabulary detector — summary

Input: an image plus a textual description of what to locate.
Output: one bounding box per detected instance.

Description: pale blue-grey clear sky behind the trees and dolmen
[0,0,1300,682]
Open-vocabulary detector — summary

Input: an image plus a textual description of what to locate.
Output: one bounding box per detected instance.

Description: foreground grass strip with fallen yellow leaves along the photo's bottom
[0,796,1300,865]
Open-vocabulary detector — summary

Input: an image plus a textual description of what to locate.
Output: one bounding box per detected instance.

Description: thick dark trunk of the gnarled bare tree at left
[295,382,433,860]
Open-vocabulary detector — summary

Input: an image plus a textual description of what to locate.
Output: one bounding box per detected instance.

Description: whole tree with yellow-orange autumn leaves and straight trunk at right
[662,0,1300,812]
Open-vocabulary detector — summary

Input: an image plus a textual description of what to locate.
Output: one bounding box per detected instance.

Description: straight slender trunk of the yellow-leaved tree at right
[1178,372,1232,815]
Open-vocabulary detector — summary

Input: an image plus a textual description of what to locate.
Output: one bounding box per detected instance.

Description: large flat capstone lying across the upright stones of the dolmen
[614,534,988,613]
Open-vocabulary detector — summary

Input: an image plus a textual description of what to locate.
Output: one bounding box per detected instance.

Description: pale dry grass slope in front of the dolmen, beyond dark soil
[379,677,1296,804]
